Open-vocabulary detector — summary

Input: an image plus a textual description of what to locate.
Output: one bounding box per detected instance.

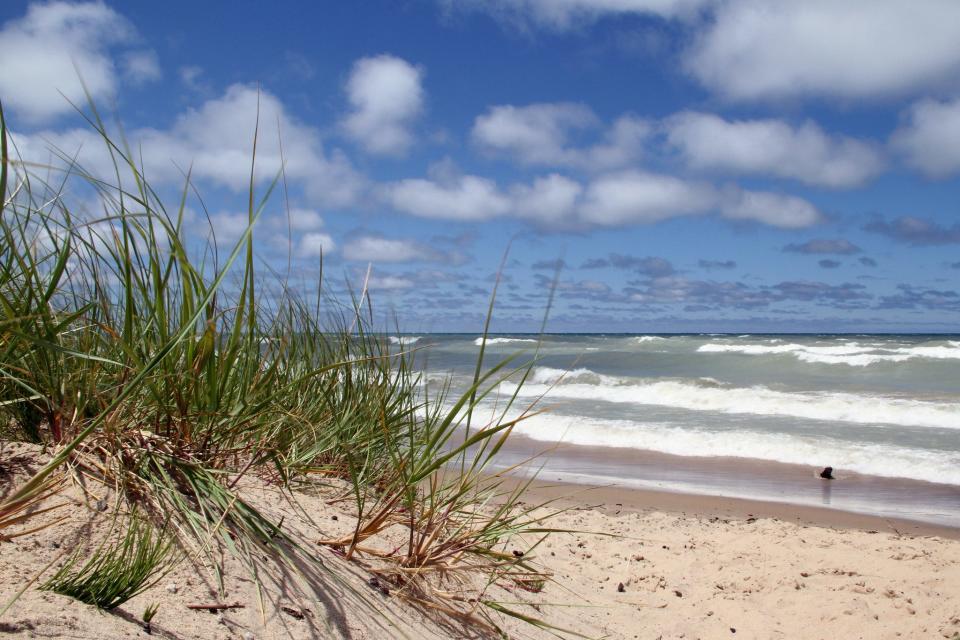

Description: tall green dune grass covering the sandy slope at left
[0,99,568,629]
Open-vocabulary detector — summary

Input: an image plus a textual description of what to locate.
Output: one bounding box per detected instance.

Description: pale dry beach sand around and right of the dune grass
[0,447,960,639]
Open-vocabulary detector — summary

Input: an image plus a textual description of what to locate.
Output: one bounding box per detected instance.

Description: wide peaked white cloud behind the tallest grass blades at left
[15,84,365,206]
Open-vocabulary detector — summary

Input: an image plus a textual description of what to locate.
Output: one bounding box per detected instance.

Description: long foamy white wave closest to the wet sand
[515,414,960,484]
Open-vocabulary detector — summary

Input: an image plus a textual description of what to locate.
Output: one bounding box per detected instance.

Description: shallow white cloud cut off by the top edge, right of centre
[440,0,712,31]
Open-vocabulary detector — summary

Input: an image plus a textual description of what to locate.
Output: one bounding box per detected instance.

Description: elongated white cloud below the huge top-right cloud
[664,112,883,187]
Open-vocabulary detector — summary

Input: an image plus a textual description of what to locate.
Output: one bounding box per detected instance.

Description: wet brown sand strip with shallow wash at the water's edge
[499,434,960,528]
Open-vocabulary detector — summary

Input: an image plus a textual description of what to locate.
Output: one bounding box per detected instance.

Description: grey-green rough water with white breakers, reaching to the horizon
[392,334,960,526]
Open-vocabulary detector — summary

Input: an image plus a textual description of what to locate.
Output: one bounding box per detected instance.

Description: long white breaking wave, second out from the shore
[502,367,960,429]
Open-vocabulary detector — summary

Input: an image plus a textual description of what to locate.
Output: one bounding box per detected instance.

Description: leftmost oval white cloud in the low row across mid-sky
[384,175,511,220]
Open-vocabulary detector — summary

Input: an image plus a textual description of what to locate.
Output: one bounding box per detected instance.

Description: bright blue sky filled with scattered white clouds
[0,0,960,333]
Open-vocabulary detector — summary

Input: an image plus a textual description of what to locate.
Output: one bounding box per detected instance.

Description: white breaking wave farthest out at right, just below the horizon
[697,340,960,367]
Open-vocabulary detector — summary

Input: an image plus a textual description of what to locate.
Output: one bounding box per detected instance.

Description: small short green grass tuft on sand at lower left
[40,516,173,608]
